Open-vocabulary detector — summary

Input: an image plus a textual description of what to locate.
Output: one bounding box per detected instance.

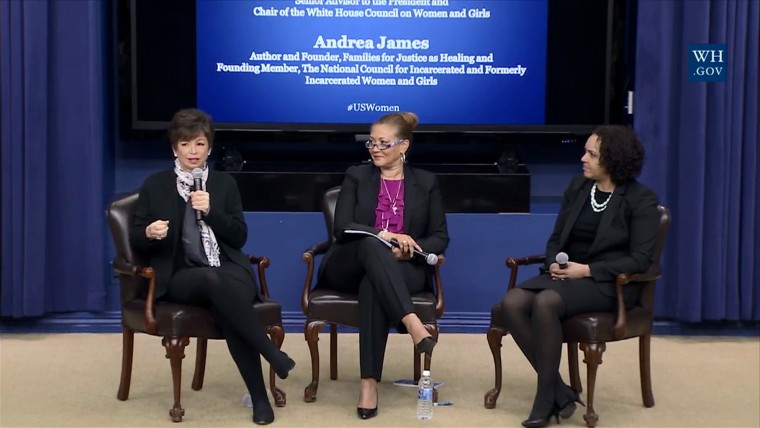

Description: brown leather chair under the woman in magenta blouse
[301,186,445,402]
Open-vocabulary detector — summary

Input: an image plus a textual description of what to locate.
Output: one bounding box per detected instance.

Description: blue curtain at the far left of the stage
[0,0,108,317]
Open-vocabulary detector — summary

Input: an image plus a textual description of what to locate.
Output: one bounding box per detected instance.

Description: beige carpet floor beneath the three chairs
[0,334,760,427]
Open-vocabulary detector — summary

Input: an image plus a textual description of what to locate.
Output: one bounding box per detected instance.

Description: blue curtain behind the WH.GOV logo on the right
[634,0,760,322]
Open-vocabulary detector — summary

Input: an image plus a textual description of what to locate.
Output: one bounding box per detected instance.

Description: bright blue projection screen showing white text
[196,0,547,128]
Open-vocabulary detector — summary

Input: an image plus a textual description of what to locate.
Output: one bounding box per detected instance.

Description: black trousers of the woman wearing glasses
[320,237,427,382]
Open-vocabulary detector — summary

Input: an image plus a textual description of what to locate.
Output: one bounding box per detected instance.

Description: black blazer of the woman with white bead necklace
[546,175,660,296]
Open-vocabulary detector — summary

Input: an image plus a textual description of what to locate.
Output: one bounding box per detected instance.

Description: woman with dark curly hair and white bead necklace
[502,126,660,427]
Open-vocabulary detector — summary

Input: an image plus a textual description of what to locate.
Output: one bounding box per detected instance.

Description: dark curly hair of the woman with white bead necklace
[594,125,644,184]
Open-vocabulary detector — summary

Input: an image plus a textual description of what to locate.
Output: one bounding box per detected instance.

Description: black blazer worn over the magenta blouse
[318,165,449,288]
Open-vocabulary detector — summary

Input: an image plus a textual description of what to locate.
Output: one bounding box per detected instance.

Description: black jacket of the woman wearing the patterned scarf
[129,169,261,300]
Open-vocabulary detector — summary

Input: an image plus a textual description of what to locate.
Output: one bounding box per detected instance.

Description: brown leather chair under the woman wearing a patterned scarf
[108,193,285,422]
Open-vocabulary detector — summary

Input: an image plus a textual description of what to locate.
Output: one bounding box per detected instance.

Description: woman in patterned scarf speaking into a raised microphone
[130,109,295,425]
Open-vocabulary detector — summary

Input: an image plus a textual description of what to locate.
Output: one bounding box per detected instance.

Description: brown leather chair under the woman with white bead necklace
[484,206,670,427]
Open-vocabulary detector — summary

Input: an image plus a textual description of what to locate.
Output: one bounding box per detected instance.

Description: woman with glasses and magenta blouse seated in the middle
[316,113,449,419]
